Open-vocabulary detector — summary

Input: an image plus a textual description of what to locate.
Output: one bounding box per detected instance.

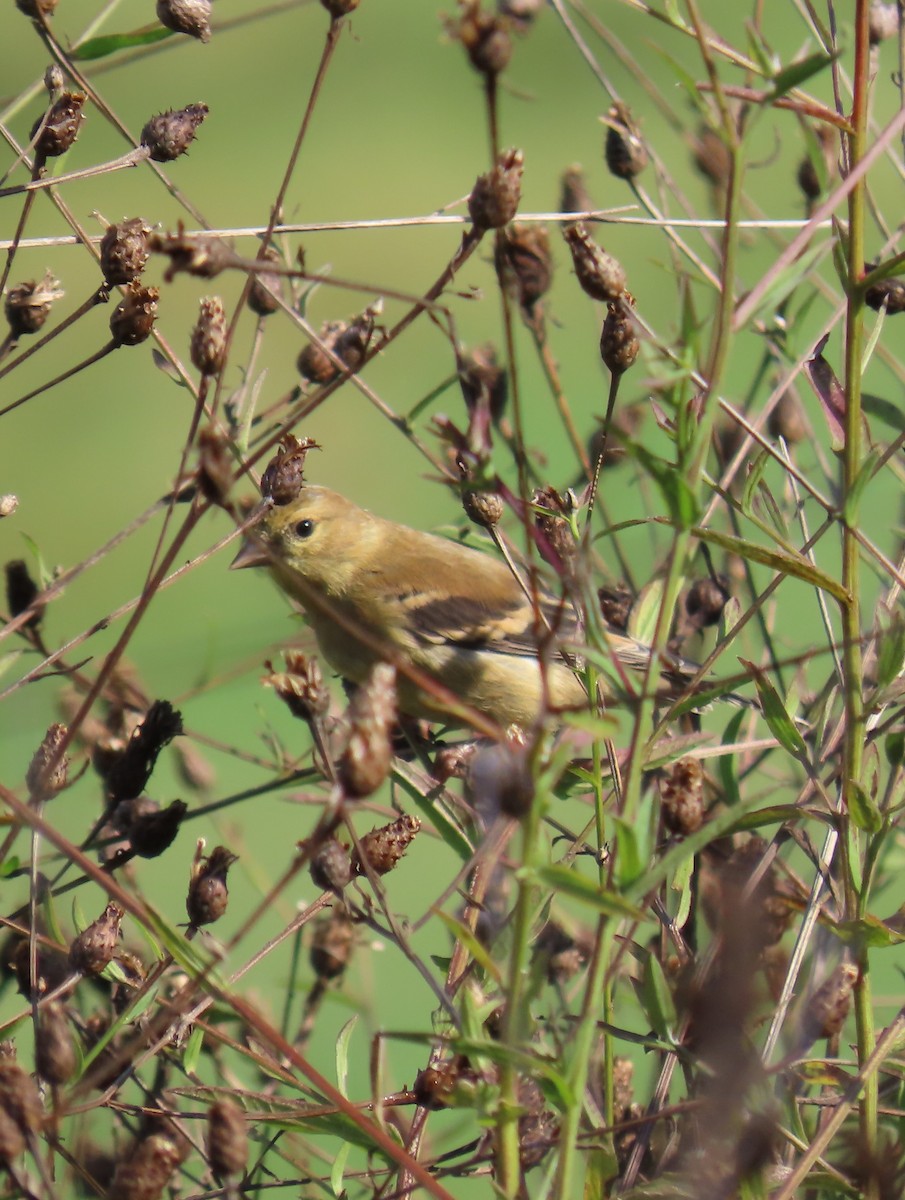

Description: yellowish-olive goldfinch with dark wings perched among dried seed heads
[232,484,691,727]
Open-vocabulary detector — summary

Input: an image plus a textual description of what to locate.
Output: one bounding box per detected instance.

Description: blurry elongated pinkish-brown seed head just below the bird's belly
[337,662,396,798]
